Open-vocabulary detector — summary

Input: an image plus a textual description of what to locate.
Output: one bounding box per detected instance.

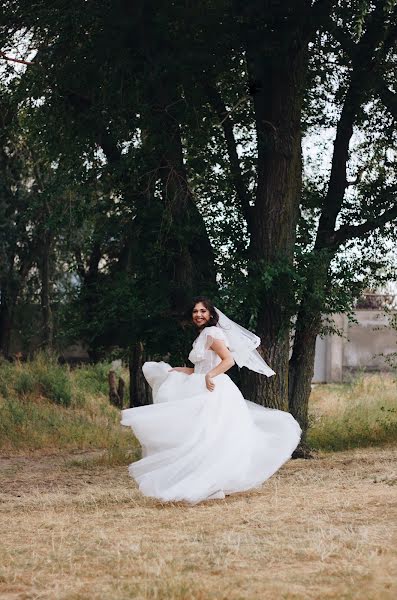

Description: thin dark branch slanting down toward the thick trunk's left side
[205,83,252,229]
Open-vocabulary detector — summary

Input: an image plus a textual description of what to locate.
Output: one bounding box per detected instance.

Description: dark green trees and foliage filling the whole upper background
[0,0,397,424]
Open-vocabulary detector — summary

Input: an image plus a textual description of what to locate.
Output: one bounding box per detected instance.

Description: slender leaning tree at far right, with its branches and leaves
[289,1,397,446]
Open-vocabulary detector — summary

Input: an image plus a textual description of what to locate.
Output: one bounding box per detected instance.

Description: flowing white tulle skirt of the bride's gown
[121,362,301,504]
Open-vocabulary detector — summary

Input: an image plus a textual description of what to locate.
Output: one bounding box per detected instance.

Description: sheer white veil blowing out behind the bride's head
[215,307,276,377]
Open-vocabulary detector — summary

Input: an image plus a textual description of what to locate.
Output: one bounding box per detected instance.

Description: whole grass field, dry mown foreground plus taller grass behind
[0,356,397,600]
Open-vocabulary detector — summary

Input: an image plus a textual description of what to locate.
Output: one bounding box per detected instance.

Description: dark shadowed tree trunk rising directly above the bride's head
[148,77,216,312]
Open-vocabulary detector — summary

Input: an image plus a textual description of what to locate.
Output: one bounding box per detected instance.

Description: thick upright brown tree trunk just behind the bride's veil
[240,16,307,410]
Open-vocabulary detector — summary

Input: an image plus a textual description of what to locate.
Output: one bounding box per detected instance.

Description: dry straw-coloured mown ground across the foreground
[0,448,397,600]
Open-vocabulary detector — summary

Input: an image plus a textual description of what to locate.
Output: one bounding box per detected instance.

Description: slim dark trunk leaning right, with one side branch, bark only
[288,0,395,440]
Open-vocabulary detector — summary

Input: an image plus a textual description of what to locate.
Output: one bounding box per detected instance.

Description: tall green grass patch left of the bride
[0,353,138,454]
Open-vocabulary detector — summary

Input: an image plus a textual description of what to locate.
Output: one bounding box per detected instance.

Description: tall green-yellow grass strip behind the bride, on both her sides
[0,353,397,458]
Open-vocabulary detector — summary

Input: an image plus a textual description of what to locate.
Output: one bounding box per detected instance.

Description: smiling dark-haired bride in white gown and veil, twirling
[121,297,301,504]
